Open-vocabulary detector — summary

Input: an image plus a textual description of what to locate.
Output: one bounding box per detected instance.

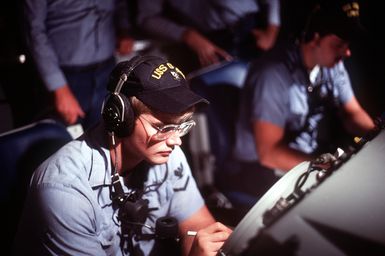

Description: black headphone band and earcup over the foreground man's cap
[101,55,160,137]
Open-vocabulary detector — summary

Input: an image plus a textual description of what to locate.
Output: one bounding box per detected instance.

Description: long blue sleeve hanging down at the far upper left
[24,0,67,91]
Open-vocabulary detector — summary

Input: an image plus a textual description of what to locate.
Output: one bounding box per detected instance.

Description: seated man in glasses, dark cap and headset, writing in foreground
[14,56,231,255]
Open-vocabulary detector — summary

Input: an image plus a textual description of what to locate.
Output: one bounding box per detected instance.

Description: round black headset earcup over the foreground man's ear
[102,93,135,137]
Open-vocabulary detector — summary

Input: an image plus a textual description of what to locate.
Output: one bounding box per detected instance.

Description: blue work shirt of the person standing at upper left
[24,0,129,91]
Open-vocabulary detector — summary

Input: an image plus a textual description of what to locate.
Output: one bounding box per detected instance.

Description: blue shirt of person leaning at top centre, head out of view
[137,0,281,41]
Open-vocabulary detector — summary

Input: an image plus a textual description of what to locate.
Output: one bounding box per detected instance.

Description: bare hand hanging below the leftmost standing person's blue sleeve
[53,85,85,125]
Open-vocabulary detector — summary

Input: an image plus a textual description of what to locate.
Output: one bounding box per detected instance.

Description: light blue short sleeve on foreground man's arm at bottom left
[34,184,108,256]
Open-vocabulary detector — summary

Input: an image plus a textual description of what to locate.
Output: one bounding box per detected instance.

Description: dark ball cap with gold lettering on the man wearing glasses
[108,56,209,114]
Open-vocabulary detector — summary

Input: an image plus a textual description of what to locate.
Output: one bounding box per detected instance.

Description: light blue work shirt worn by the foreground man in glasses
[15,124,204,256]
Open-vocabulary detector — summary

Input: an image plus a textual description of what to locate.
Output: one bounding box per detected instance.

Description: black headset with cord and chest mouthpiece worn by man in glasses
[101,55,178,249]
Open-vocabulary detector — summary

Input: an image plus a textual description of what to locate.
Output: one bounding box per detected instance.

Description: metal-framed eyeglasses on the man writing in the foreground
[139,115,195,140]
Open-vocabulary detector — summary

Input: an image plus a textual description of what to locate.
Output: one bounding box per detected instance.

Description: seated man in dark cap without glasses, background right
[218,0,374,208]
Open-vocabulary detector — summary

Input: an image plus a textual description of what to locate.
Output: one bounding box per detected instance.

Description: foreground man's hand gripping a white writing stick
[189,222,232,256]
